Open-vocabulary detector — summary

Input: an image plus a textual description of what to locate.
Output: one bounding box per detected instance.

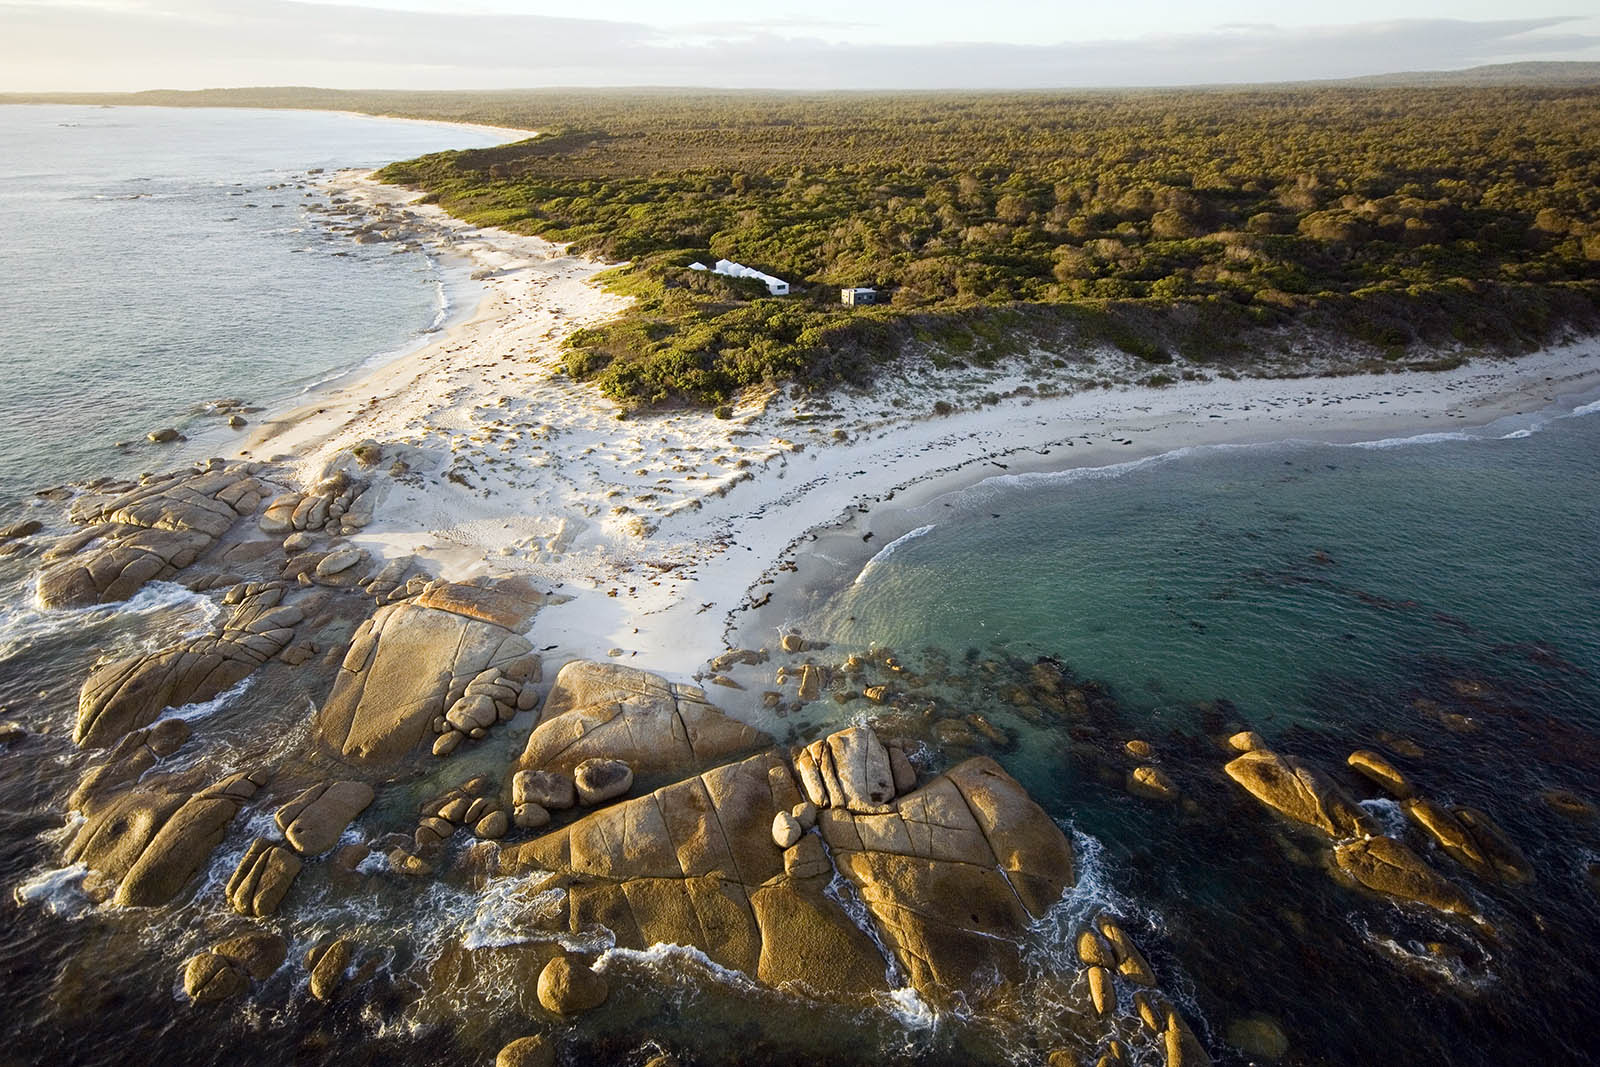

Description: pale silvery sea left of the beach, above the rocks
[0,106,514,510]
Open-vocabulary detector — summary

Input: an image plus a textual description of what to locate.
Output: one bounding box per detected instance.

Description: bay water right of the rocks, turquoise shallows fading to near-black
[781,398,1600,1065]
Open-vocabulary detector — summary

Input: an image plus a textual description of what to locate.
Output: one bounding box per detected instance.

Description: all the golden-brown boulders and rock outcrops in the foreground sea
[14,435,1582,1065]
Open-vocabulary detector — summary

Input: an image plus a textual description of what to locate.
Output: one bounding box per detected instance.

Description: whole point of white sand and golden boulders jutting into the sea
[0,167,1595,1067]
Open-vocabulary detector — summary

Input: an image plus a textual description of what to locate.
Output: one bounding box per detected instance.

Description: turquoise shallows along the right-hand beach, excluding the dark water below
[803,399,1600,733]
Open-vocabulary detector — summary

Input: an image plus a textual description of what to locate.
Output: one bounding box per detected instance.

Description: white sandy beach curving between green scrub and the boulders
[232,173,1600,678]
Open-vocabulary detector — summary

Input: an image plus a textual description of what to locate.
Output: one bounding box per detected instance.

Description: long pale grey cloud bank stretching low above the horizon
[0,0,1600,90]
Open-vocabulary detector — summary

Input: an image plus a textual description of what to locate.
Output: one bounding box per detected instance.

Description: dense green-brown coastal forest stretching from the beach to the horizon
[15,85,1600,403]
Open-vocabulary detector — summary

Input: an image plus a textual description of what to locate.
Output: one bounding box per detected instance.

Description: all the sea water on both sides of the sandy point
[0,107,1600,1067]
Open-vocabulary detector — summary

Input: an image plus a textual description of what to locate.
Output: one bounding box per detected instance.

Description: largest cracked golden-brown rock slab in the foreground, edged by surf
[501,726,1074,1006]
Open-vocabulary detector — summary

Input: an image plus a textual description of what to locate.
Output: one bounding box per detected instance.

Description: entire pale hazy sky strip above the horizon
[0,0,1600,91]
